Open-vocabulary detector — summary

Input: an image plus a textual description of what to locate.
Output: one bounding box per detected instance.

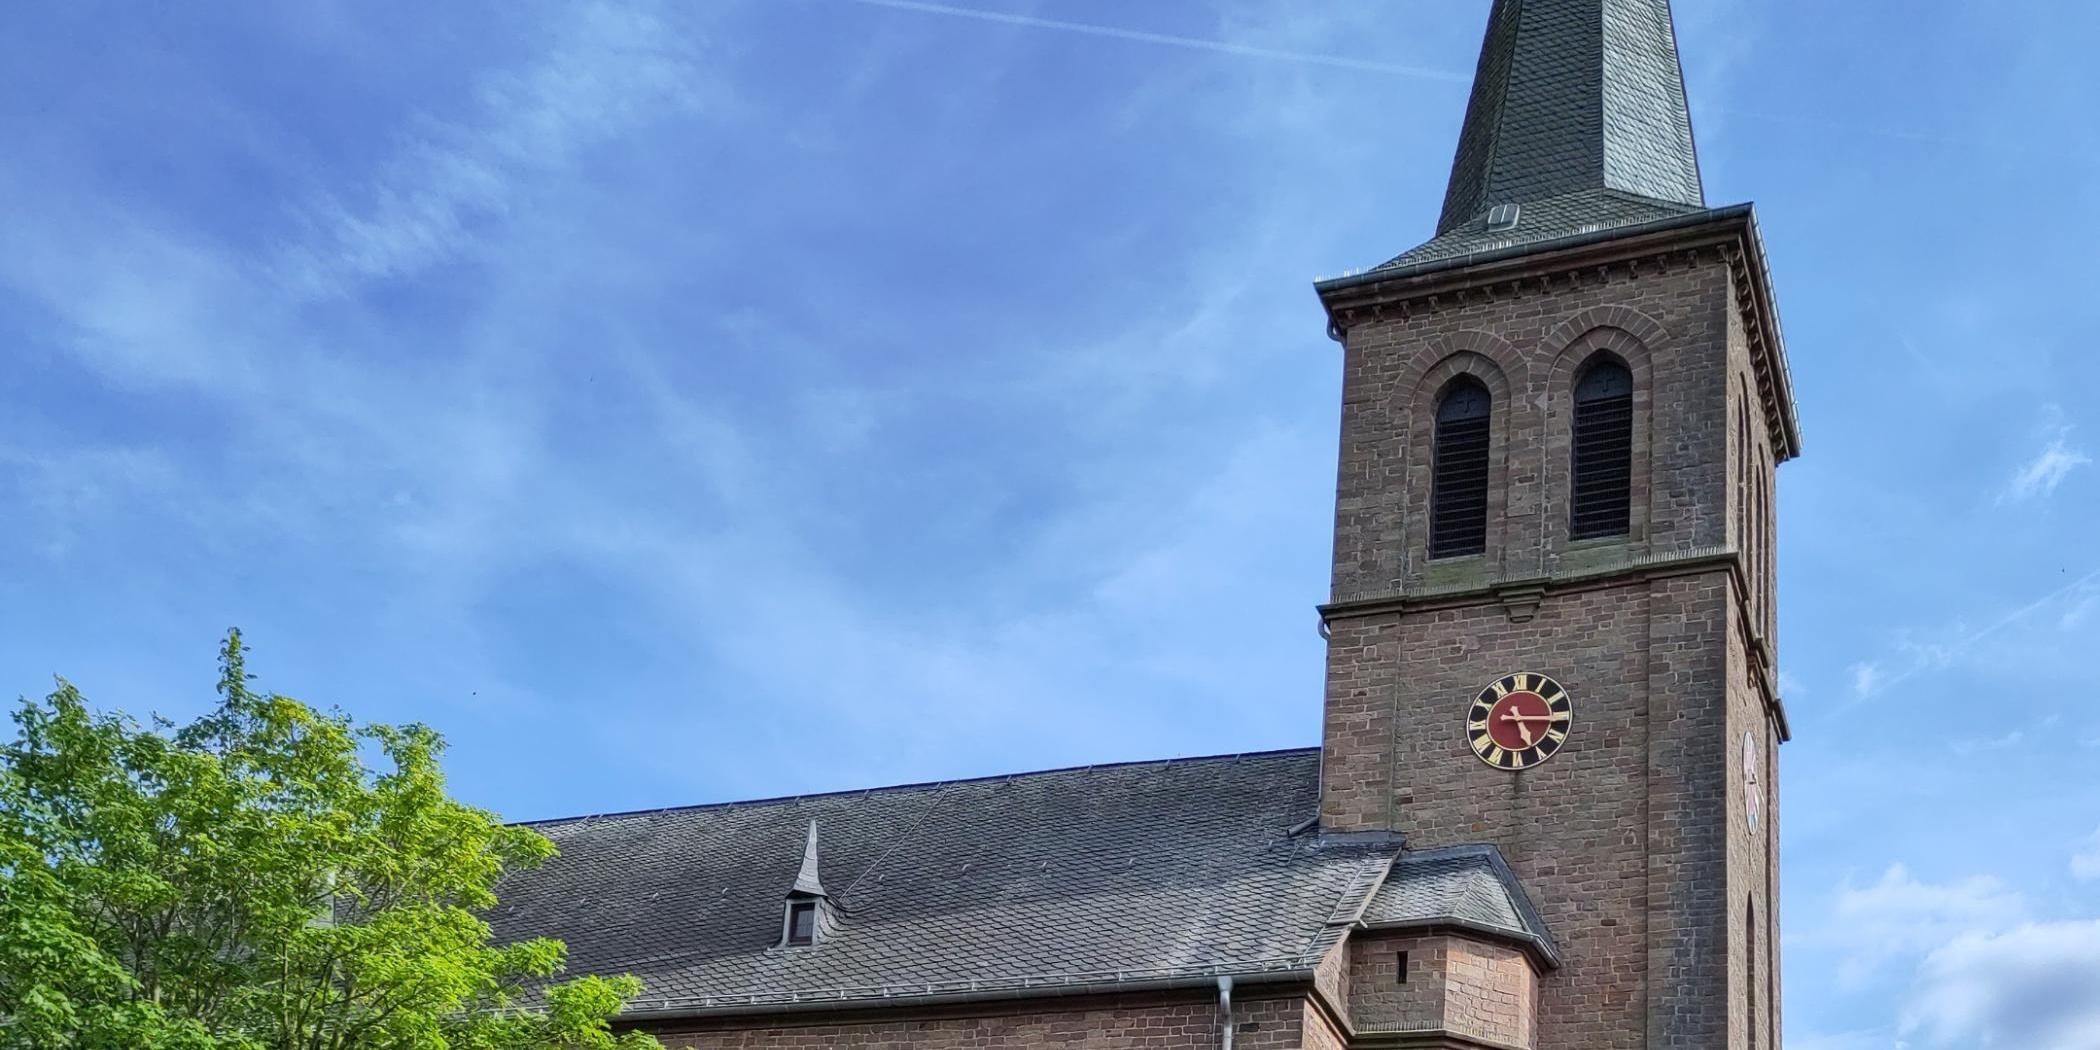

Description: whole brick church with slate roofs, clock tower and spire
[491,0,1800,1050]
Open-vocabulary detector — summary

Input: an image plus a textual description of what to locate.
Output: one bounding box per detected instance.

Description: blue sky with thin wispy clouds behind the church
[0,0,2100,1050]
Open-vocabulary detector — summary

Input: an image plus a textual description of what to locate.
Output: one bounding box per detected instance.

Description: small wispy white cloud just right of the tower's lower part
[1833,863,2027,987]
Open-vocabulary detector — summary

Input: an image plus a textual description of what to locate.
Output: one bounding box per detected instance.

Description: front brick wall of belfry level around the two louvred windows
[1334,252,1735,603]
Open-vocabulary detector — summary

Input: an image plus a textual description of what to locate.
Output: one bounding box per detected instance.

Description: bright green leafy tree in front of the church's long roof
[0,632,657,1050]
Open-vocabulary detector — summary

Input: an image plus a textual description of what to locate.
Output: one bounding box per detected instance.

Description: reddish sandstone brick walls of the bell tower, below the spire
[1321,241,1777,1050]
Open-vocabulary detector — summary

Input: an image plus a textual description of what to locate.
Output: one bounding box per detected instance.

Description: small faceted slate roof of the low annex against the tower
[1363,846,1560,966]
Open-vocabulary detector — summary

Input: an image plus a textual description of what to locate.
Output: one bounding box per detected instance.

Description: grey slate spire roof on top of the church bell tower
[1386,0,1705,267]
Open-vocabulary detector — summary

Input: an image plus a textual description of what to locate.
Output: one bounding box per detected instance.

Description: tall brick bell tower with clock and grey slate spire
[1317,0,1800,1050]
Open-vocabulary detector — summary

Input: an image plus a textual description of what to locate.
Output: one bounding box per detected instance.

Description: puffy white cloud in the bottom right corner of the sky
[1903,920,2100,1050]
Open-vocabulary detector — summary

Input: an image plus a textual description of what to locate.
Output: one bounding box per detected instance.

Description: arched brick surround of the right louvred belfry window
[1539,325,1663,552]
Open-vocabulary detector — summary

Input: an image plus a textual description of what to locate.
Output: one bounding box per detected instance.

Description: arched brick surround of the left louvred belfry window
[1394,340,1525,578]
